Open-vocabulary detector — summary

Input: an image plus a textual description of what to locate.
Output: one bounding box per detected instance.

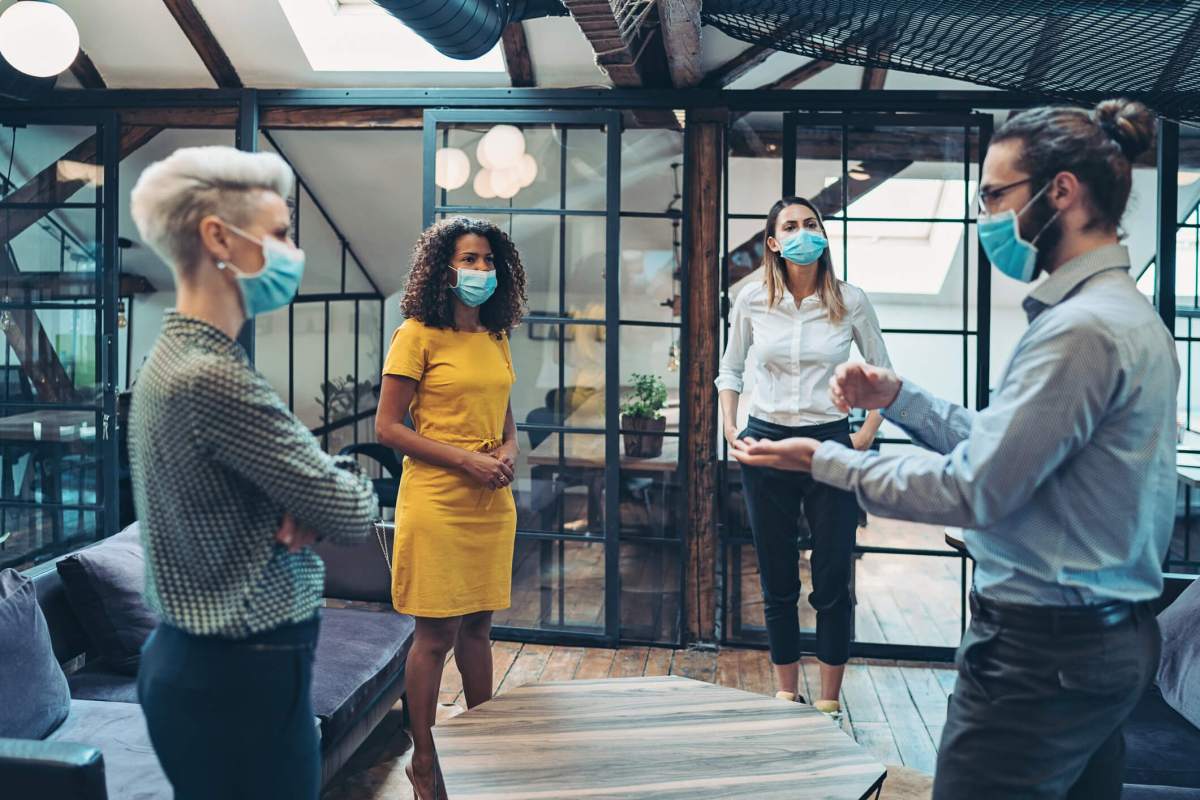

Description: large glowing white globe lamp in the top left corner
[0,0,79,78]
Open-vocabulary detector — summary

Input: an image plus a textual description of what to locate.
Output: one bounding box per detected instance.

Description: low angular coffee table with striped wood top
[433,676,887,800]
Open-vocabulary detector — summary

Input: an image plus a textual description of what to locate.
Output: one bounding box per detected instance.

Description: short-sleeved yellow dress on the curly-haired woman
[383,319,517,618]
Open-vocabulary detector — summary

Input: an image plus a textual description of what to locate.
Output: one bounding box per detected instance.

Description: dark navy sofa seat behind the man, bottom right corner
[1124,686,1200,788]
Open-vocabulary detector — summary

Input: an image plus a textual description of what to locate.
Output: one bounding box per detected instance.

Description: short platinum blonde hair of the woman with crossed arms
[130,146,295,273]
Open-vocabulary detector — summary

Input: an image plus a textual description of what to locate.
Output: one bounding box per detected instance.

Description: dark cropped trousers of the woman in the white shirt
[742,417,858,666]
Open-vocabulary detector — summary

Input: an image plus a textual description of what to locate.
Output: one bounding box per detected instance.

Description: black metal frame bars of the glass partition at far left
[0,106,120,567]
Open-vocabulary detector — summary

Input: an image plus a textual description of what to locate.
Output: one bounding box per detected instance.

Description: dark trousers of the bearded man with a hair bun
[934,599,1160,800]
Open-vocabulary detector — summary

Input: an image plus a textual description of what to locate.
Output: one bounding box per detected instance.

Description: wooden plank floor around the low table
[323,642,954,800]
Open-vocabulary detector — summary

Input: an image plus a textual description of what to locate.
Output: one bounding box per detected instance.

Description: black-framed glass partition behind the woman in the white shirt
[718,112,991,657]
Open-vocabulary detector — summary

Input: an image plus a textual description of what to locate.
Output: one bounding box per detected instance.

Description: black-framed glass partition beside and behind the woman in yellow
[425,112,686,644]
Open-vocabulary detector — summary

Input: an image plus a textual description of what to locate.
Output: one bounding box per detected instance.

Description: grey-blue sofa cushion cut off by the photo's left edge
[0,570,71,739]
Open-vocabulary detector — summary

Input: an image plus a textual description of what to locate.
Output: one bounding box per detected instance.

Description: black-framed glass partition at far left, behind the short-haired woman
[0,112,117,567]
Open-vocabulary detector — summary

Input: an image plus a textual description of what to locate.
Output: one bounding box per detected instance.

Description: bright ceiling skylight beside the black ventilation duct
[278,0,504,74]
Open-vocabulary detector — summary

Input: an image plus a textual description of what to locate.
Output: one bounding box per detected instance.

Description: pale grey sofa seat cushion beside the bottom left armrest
[49,700,173,800]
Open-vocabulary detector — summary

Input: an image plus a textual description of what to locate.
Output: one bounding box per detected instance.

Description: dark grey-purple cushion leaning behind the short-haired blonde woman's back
[58,524,158,675]
